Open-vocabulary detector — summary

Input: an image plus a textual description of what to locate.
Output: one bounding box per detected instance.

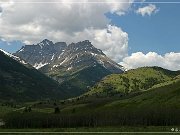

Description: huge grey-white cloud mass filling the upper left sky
[0,0,133,62]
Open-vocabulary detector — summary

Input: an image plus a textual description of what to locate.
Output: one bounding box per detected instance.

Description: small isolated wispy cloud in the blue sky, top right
[136,4,159,16]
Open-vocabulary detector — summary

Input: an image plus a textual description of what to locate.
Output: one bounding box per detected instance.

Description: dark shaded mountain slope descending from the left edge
[0,51,65,101]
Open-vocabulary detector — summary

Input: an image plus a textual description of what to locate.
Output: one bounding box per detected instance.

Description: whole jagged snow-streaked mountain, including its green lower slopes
[14,39,124,96]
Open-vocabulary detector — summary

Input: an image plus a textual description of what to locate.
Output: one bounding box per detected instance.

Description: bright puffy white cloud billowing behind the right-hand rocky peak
[73,25,128,62]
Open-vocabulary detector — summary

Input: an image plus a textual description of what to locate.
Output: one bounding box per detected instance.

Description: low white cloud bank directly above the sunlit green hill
[120,52,180,71]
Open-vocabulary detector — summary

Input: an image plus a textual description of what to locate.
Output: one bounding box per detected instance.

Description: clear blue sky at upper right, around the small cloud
[107,4,180,54]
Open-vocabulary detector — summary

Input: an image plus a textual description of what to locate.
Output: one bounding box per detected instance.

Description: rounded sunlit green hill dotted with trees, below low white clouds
[85,67,180,96]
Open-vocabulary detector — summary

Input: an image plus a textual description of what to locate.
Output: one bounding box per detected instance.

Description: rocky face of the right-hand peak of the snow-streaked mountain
[42,40,123,73]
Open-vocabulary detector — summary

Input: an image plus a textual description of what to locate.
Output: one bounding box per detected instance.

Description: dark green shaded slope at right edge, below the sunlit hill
[106,78,180,107]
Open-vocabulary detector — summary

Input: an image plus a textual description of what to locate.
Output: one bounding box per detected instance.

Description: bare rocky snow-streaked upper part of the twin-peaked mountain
[15,39,123,73]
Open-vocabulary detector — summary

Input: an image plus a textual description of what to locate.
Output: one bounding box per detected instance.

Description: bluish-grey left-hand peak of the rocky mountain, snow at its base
[14,39,67,69]
